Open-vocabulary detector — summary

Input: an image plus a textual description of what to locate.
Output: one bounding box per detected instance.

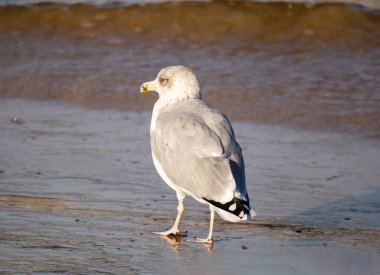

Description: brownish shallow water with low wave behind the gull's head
[0,1,380,139]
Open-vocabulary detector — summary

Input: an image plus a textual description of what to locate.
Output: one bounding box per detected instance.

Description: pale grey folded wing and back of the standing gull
[151,100,248,203]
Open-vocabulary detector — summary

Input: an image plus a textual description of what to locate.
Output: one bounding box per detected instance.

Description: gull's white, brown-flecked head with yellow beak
[140,66,201,103]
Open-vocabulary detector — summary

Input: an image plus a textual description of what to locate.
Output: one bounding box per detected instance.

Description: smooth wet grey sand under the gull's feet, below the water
[0,99,380,274]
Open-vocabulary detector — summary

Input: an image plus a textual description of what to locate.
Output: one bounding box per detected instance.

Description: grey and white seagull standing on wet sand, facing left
[140,66,256,244]
